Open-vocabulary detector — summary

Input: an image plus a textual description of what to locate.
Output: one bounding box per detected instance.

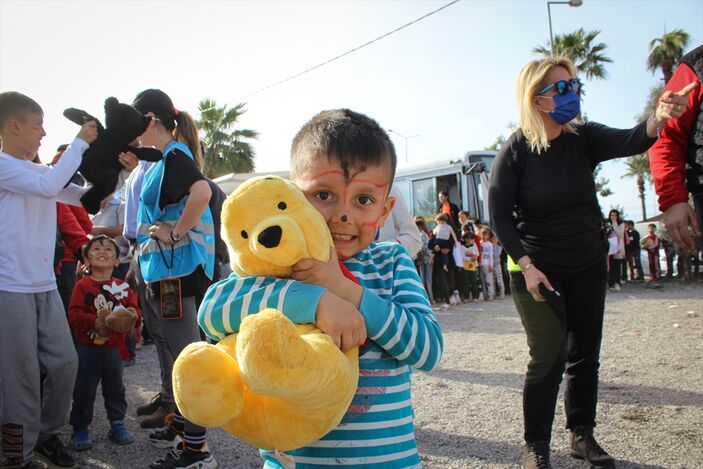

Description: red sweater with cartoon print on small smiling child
[68,277,142,360]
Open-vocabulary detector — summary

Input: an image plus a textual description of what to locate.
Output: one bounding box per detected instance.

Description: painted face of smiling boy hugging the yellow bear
[295,157,395,259]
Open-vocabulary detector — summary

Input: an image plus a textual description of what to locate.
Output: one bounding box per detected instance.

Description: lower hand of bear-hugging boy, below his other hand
[315,292,366,352]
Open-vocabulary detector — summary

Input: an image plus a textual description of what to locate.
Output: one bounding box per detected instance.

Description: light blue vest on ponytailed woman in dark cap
[137,141,215,282]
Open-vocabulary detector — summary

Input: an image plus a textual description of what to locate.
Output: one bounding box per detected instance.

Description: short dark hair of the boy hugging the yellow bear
[290,109,396,188]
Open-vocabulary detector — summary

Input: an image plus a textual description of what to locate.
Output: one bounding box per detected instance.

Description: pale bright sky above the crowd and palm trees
[0,0,703,218]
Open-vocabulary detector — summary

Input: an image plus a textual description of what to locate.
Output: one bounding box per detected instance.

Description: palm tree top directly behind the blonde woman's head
[532,28,613,80]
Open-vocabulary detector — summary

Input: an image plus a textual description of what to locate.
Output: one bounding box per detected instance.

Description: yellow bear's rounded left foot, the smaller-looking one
[173,342,244,427]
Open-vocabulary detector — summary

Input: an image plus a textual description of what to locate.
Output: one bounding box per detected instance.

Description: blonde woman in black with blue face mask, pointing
[488,57,683,469]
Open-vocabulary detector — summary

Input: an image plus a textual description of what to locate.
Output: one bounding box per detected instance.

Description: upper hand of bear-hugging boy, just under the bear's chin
[291,247,362,305]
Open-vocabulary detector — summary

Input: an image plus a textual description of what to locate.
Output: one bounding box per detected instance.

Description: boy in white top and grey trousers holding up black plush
[0,91,98,467]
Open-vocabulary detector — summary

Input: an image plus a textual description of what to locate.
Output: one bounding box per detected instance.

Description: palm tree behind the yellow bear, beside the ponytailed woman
[197,99,259,179]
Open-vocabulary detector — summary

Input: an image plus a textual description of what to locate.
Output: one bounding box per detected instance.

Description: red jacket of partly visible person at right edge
[649,63,703,212]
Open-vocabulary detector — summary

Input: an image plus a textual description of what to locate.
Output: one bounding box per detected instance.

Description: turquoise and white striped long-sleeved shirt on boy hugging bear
[198,243,443,469]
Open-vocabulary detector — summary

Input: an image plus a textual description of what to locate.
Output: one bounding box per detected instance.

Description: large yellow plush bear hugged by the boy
[173,176,359,451]
